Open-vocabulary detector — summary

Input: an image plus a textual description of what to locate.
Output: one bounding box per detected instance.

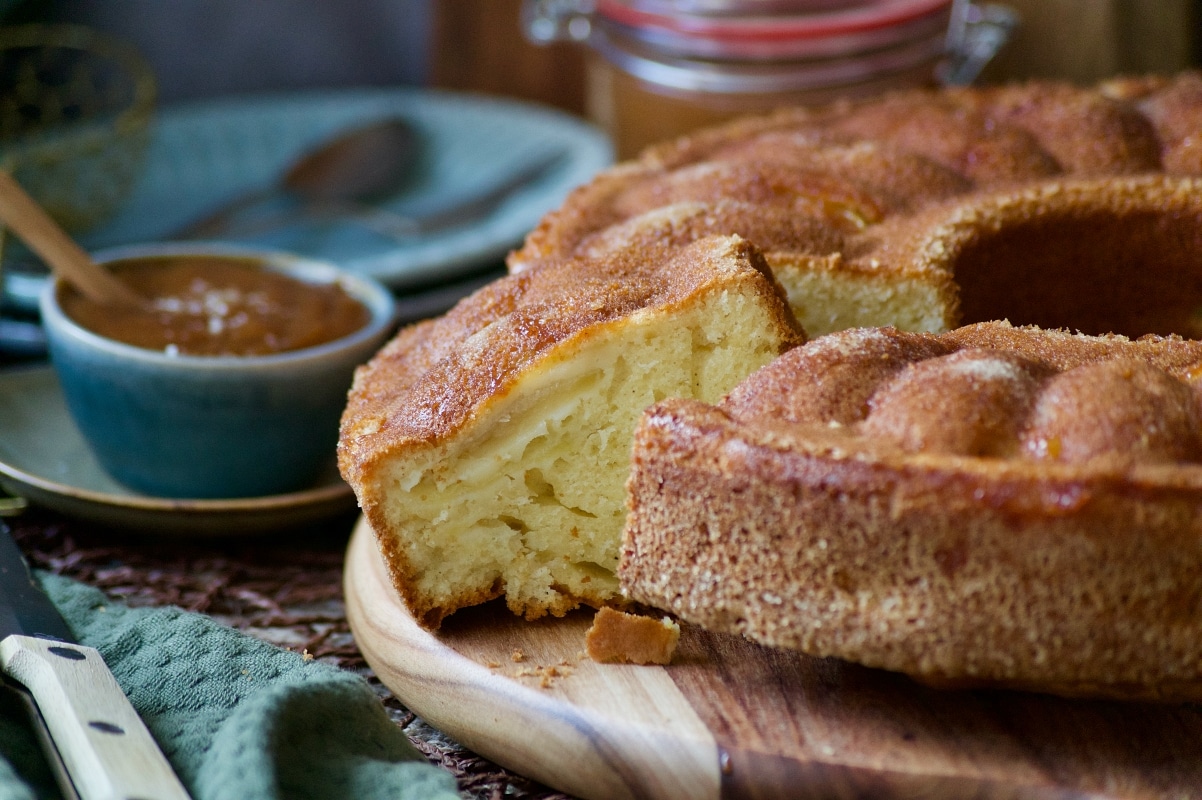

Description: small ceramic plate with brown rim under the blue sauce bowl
[0,366,355,536]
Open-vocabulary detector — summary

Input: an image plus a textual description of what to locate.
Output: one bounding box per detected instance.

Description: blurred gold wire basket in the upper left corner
[0,25,157,232]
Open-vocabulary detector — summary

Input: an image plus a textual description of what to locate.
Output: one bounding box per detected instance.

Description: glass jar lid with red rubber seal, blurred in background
[596,0,953,58]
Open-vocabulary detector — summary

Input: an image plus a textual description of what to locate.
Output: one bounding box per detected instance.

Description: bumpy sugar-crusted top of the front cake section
[722,322,1202,464]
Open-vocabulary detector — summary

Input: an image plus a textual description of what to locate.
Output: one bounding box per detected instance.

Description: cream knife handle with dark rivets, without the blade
[0,635,188,800]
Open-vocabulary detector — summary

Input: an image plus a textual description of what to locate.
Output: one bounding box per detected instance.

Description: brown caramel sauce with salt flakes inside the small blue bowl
[59,255,370,356]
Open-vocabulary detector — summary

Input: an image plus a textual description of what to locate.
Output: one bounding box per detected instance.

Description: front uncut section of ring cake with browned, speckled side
[619,322,1202,700]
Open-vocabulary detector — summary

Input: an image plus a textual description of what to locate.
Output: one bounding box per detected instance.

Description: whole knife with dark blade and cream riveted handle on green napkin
[0,520,188,800]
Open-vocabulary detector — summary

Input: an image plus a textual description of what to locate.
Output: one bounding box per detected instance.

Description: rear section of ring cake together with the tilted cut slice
[339,73,1202,658]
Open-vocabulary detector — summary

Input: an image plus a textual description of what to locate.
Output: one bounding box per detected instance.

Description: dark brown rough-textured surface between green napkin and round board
[6,508,567,800]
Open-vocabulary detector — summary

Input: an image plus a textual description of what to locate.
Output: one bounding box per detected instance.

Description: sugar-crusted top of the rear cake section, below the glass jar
[510,73,1202,279]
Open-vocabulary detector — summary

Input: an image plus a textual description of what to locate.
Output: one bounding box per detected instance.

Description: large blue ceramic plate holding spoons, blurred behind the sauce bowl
[5,89,613,309]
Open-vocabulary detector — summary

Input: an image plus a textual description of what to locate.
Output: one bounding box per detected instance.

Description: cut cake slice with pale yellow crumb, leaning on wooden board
[339,237,804,628]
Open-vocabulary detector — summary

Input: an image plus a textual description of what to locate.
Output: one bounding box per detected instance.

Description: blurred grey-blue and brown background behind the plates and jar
[0,0,1202,120]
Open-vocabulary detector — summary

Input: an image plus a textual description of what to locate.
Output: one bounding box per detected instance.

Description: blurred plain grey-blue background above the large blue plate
[0,0,430,103]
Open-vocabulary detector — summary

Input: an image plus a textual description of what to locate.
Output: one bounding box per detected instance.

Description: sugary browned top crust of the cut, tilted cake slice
[339,237,804,479]
